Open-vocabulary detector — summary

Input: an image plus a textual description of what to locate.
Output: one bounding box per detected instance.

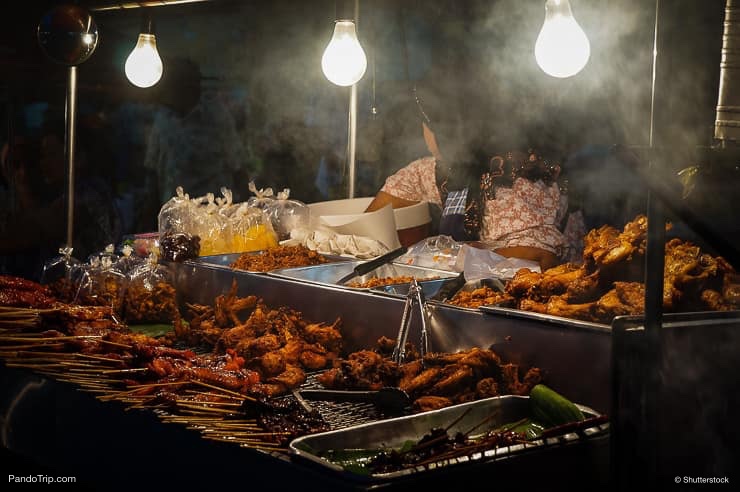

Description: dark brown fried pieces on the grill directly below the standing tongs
[318,337,542,412]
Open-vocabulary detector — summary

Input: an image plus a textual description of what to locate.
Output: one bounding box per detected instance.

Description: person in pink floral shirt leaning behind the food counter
[367,85,578,270]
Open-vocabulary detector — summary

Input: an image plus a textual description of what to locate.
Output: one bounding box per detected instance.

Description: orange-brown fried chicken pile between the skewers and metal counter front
[174,281,342,396]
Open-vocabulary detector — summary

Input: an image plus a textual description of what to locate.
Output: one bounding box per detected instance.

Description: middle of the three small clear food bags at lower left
[75,256,128,315]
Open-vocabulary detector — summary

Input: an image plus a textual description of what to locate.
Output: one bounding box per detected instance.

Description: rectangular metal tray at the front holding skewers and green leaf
[290,395,609,482]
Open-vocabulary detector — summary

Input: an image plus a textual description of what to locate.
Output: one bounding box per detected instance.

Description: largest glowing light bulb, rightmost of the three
[534,0,591,78]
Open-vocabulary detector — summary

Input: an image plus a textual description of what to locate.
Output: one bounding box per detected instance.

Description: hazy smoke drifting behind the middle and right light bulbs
[92,0,724,215]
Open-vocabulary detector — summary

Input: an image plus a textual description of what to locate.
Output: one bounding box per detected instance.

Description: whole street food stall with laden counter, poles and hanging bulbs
[0,0,740,490]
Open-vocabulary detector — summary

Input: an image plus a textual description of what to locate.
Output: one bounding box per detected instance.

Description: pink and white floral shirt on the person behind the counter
[381,157,582,256]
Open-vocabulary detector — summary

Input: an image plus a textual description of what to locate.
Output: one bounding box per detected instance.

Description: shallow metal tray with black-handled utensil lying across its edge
[269,261,457,291]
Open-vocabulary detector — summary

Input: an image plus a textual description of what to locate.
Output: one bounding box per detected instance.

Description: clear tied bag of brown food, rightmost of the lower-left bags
[123,254,180,324]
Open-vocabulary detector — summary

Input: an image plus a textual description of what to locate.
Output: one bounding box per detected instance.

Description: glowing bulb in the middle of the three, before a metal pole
[321,20,367,86]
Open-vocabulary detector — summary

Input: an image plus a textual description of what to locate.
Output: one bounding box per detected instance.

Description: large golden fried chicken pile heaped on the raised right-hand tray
[506,215,740,324]
